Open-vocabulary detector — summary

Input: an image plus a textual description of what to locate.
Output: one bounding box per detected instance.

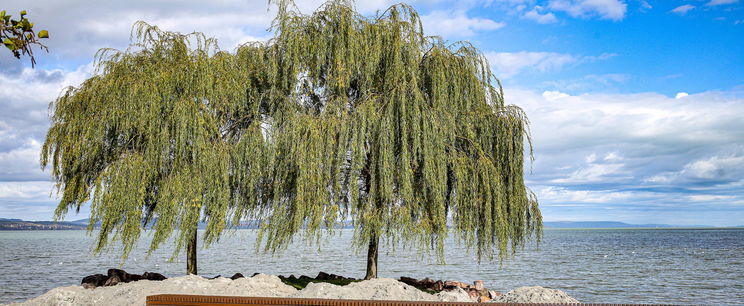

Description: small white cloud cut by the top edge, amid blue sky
[548,0,628,21]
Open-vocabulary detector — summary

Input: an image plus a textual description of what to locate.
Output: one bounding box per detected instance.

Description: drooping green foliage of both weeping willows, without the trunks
[42,1,542,259]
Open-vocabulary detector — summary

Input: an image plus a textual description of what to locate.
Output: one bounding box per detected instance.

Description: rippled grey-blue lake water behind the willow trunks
[0,229,744,305]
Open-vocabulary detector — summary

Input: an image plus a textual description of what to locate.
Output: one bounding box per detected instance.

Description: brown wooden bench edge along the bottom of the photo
[147,294,668,306]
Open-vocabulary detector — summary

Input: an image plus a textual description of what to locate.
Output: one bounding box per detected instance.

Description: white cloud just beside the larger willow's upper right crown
[421,11,506,38]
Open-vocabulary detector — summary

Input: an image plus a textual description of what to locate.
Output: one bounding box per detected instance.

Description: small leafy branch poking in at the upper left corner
[0,11,49,67]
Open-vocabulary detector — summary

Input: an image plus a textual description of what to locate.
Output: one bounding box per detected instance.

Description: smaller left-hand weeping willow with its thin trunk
[41,22,265,274]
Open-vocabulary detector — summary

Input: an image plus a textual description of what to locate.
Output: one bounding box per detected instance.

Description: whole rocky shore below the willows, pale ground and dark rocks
[11,269,578,305]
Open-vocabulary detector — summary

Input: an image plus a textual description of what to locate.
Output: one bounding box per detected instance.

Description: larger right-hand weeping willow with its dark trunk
[254,1,542,279]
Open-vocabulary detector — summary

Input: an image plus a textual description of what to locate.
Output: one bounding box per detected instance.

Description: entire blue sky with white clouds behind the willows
[0,0,744,226]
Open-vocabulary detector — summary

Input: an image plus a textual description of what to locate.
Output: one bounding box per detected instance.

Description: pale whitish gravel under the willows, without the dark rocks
[11,274,577,306]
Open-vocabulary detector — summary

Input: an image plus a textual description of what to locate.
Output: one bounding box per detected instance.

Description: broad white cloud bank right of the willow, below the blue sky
[506,88,744,154]
